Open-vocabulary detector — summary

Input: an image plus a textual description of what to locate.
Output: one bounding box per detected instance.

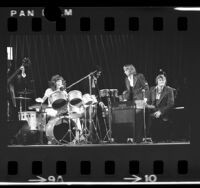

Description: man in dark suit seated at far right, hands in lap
[147,74,174,141]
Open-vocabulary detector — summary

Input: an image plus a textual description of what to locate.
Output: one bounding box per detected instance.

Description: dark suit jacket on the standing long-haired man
[125,74,149,100]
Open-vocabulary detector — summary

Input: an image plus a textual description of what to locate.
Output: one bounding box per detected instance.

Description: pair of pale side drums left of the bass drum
[18,111,46,131]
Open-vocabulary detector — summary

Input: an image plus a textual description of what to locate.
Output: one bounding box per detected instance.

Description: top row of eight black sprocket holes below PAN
[7,17,188,32]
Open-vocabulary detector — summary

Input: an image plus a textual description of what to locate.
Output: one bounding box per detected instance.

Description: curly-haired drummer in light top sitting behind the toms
[35,74,68,107]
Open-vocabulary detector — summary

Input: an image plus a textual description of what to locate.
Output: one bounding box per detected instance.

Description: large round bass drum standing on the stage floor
[46,117,76,144]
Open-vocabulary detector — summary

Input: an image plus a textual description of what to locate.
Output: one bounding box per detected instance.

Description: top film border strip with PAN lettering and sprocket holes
[7,7,193,34]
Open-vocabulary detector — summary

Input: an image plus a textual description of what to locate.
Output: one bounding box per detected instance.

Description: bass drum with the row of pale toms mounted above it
[46,90,100,144]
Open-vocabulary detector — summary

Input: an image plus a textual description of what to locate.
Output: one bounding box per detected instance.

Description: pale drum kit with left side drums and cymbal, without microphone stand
[16,90,98,144]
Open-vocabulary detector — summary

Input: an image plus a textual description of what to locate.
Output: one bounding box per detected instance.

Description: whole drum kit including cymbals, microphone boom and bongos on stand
[15,71,125,144]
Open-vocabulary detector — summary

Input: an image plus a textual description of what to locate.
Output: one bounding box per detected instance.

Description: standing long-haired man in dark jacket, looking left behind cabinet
[123,64,149,143]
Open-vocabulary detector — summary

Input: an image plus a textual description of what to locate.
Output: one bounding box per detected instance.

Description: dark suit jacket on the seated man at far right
[147,86,174,115]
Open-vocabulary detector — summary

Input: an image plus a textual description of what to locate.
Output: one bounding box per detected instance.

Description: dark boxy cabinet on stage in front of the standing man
[111,102,135,143]
